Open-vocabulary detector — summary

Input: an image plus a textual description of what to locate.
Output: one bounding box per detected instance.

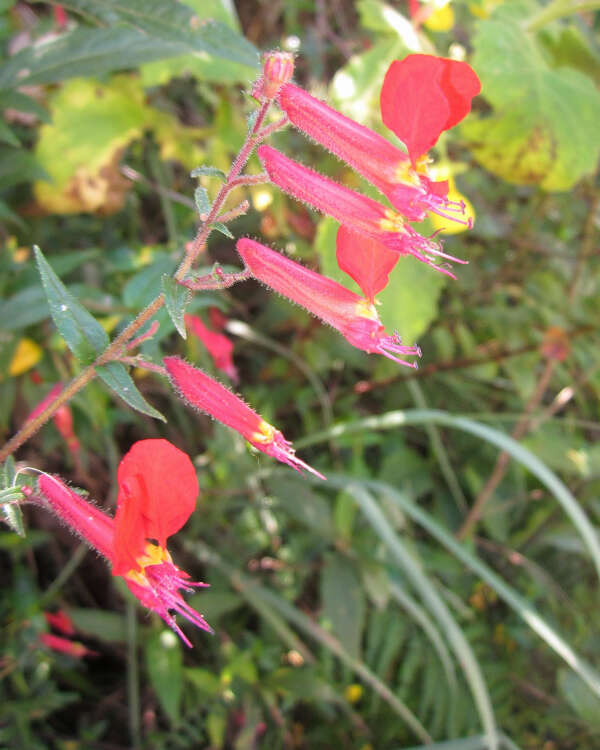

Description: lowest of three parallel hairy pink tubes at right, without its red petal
[236,238,421,367]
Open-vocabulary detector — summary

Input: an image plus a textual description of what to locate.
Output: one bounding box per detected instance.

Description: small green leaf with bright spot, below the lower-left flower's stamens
[145,630,183,724]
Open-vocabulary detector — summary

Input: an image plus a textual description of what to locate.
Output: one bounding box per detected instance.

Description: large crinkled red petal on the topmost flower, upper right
[380,55,481,165]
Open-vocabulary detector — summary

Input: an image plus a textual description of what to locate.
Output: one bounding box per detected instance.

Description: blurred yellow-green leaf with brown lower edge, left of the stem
[34,75,202,215]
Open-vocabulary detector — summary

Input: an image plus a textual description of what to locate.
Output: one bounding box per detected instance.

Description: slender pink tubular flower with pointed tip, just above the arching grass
[163,357,325,479]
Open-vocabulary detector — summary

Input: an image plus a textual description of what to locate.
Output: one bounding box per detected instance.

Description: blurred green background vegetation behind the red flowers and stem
[0,0,600,750]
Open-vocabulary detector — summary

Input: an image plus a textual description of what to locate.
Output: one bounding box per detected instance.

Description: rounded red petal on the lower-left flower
[113,440,198,574]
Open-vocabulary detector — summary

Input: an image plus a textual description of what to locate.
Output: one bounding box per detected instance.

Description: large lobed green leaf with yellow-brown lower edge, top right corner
[461,3,600,190]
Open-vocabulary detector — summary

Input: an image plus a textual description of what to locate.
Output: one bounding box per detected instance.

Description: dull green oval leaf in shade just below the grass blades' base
[321,555,366,659]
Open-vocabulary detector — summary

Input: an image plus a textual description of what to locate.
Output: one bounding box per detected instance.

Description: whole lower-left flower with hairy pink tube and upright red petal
[32,439,212,646]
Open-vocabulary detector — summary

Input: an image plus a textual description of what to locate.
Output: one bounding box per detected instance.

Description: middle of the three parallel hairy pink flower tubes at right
[257,146,466,278]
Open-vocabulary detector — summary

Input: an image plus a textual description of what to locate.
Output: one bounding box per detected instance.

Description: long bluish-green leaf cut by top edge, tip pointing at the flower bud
[49,0,258,68]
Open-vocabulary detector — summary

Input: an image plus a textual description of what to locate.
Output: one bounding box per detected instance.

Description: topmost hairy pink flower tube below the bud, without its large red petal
[279,83,467,224]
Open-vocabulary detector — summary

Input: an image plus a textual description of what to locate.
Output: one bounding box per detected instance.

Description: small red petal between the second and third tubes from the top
[337,225,400,302]
